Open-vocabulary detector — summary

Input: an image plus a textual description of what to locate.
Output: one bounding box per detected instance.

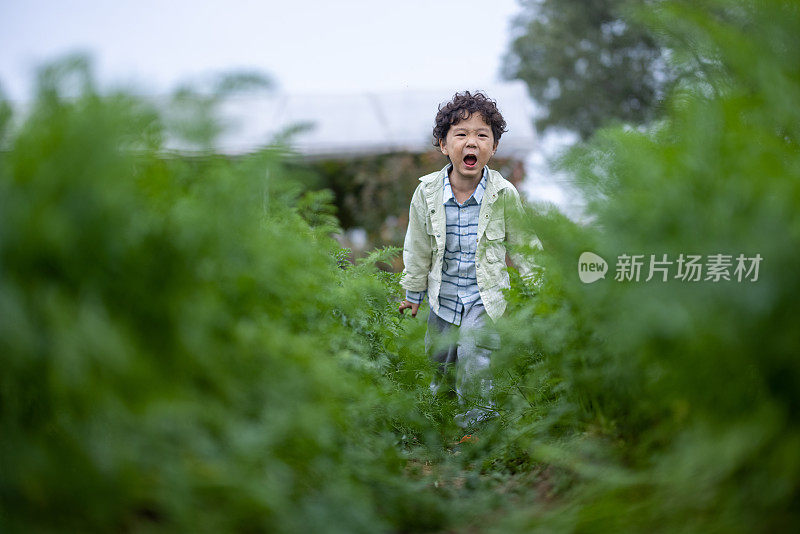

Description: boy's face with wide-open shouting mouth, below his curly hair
[439,113,497,180]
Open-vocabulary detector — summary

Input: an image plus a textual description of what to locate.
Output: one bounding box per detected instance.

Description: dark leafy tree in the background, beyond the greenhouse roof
[503,0,674,139]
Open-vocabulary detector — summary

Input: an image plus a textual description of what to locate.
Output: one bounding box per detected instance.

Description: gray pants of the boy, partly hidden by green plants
[425,301,500,427]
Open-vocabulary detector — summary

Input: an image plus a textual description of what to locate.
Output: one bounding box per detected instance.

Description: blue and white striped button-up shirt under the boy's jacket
[406,167,487,326]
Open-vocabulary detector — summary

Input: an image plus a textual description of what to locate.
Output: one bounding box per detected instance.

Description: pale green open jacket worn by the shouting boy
[400,167,531,320]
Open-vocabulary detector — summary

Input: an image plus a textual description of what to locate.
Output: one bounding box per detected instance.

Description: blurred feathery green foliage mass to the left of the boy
[0,56,447,533]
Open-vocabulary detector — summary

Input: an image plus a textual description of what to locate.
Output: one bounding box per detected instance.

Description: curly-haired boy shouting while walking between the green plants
[399,91,530,427]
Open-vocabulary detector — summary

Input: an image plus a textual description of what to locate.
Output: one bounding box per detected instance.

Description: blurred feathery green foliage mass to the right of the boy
[494,0,800,532]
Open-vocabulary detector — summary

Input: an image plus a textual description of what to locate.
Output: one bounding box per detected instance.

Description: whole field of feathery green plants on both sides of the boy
[0,0,800,534]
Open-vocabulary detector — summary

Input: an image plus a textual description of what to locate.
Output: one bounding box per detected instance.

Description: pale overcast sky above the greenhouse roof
[0,0,520,99]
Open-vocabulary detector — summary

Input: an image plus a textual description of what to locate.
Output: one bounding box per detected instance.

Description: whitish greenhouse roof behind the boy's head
[219,82,536,159]
